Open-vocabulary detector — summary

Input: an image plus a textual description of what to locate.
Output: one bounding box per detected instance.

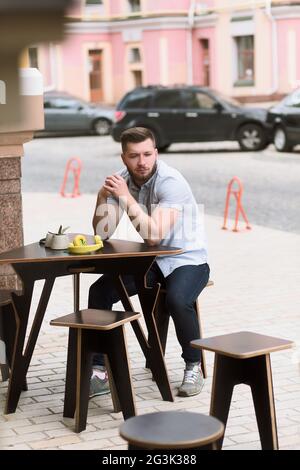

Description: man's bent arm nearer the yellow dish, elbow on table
[93,187,120,240]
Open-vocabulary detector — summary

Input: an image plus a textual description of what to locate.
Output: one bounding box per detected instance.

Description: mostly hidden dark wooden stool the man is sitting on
[146,280,214,379]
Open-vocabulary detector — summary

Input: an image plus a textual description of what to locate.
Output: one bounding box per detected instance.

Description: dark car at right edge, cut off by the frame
[268,88,300,152]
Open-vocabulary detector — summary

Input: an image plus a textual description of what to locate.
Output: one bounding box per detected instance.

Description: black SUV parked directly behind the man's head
[112,86,271,150]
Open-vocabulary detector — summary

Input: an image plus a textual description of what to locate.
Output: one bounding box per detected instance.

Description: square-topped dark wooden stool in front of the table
[50,309,141,432]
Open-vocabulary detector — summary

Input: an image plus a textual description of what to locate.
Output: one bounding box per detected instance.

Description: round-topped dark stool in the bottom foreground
[120,411,224,450]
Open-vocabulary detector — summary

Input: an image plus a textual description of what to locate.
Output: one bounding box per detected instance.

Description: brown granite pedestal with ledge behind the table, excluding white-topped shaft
[0,132,32,289]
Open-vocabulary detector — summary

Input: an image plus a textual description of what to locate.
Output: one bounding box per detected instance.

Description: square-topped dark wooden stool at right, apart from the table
[191,331,293,450]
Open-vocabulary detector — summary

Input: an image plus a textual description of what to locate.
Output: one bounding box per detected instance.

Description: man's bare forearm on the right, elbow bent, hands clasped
[103,175,179,246]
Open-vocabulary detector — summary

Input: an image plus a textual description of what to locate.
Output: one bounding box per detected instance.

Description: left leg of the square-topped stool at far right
[209,354,241,449]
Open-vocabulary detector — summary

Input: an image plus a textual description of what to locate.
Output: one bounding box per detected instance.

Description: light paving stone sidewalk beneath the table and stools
[0,193,300,450]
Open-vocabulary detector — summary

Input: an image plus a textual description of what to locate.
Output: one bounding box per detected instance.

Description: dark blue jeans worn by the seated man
[88,263,210,365]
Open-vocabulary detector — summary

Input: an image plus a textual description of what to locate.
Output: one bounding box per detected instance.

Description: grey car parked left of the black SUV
[39,92,114,135]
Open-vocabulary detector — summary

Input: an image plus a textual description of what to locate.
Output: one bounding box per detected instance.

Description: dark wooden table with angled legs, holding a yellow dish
[0,239,181,413]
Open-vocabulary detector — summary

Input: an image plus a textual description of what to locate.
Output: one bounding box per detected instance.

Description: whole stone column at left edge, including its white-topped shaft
[0,68,44,289]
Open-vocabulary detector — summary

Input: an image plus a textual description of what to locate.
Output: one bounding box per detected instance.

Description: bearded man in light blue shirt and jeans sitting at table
[88,127,209,397]
